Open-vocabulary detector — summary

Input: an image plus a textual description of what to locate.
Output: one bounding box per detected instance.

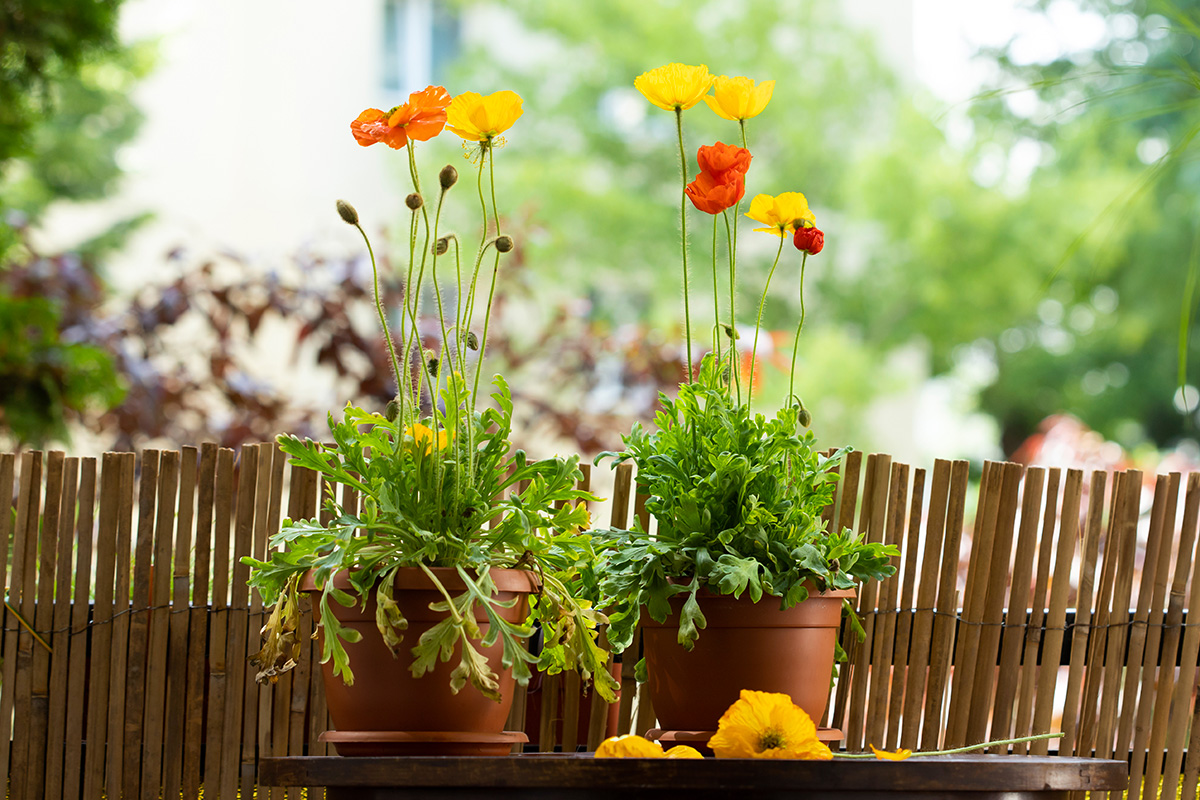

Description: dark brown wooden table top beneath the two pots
[258,754,1128,800]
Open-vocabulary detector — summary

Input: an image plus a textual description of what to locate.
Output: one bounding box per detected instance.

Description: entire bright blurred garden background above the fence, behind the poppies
[0,0,1200,469]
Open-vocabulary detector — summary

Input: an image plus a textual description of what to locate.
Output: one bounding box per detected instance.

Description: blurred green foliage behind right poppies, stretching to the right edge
[444,0,1200,452]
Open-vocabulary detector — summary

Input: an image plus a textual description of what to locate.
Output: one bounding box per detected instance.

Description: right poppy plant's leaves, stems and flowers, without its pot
[596,64,899,651]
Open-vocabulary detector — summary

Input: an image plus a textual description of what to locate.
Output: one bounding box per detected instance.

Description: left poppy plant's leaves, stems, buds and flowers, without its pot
[244,86,617,702]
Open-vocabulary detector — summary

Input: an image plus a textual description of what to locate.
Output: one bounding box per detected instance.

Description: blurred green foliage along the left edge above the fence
[0,0,149,445]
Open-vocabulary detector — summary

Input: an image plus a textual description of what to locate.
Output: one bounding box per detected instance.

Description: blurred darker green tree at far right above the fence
[971,0,1200,446]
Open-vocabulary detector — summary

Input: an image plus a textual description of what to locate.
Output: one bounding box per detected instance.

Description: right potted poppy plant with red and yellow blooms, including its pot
[595,64,899,732]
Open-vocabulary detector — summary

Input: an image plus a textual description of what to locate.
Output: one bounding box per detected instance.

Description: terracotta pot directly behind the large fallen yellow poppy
[642,590,854,730]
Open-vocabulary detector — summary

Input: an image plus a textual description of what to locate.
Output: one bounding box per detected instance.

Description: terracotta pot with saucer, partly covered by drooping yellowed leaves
[300,567,538,756]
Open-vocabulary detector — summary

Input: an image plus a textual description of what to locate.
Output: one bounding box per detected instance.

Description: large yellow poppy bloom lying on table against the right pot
[708,688,833,760]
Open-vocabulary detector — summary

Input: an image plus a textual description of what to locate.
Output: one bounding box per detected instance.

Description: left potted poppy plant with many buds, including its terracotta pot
[245,86,617,756]
